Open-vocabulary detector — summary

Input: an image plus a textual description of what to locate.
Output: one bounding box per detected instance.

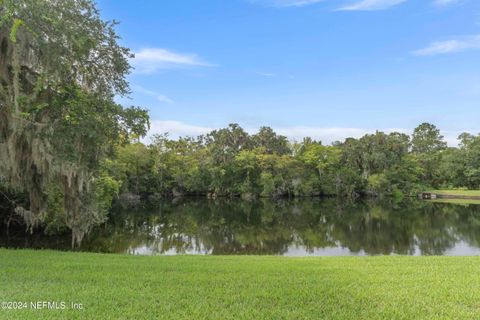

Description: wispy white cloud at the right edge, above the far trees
[413,35,480,56]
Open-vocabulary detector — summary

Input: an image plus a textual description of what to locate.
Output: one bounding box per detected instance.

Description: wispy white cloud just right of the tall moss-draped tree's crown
[132,48,213,73]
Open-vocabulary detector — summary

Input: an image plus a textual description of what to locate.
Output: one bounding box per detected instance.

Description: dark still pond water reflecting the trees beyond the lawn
[0,198,480,256]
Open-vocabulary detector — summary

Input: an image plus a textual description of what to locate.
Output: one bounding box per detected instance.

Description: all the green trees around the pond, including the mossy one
[0,0,480,244]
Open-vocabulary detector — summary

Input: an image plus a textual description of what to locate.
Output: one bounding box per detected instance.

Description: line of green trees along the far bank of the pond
[106,123,480,204]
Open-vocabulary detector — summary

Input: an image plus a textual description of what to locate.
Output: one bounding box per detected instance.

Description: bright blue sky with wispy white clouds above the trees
[98,0,480,144]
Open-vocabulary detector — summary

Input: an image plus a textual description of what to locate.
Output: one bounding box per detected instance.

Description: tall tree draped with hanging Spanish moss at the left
[0,0,148,243]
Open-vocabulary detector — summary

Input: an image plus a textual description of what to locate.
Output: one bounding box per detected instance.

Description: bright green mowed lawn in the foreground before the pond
[0,249,480,319]
